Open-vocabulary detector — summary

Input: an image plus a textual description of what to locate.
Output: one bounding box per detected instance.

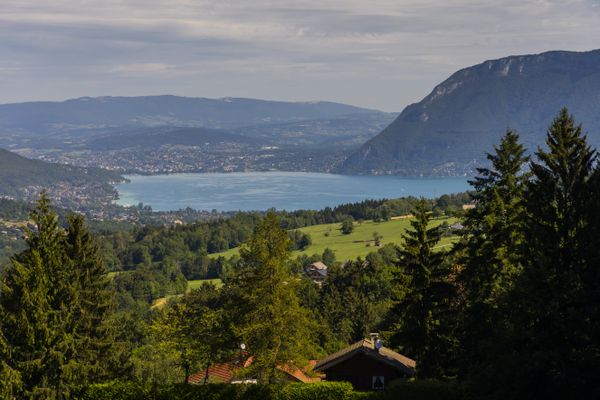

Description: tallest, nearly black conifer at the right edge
[509,109,600,398]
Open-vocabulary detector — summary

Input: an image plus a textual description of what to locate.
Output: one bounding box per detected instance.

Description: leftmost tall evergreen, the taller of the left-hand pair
[0,194,75,399]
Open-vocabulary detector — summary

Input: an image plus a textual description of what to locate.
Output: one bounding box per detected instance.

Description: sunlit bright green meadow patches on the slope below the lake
[210,218,457,261]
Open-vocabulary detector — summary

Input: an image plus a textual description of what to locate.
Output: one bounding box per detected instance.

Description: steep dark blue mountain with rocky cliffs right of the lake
[338,50,600,175]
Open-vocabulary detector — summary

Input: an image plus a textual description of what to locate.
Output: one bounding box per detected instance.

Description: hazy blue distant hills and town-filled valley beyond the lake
[0,96,397,174]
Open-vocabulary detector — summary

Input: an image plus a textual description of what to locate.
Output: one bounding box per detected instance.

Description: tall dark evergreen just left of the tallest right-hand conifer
[454,130,528,374]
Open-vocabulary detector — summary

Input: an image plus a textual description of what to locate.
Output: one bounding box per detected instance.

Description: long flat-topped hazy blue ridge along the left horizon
[0,96,382,134]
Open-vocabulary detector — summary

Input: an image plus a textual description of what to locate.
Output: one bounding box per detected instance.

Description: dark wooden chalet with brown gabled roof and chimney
[314,335,416,390]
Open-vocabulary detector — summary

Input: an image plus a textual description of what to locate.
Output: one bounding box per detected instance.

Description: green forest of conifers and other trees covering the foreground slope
[0,109,600,399]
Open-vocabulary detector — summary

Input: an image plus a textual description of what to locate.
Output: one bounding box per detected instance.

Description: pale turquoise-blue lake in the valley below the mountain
[117,172,470,211]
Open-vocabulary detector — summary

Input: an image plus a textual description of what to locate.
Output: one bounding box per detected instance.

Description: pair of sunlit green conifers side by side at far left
[0,195,119,399]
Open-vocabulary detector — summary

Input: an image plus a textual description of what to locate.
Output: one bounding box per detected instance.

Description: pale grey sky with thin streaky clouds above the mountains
[0,0,600,111]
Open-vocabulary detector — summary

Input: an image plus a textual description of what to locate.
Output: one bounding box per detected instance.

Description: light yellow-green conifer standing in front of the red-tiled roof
[225,213,312,382]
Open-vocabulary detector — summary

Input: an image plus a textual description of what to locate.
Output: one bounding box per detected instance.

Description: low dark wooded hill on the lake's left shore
[0,149,123,198]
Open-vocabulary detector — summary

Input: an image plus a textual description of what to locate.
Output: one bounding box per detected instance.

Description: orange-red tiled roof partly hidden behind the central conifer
[189,354,321,385]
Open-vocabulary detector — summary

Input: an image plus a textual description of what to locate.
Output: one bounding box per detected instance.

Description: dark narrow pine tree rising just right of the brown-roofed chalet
[391,199,456,377]
